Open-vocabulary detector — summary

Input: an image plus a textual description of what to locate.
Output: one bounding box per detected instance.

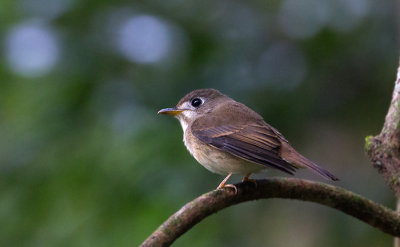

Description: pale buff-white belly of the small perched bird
[184,132,266,175]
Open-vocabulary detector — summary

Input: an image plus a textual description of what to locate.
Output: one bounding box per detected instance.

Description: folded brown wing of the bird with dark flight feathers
[192,119,296,174]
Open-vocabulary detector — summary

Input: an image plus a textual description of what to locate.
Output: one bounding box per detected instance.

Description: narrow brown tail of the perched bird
[281,143,339,181]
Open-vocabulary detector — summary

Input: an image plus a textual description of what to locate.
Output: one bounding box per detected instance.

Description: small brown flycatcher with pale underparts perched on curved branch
[158,89,338,190]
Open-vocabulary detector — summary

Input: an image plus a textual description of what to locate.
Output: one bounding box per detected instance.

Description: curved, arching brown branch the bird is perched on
[141,178,400,247]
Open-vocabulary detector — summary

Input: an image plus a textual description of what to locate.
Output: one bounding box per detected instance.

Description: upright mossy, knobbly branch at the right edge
[365,58,400,198]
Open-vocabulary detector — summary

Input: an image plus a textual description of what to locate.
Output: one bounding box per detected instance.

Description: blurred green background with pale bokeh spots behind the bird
[0,0,399,247]
